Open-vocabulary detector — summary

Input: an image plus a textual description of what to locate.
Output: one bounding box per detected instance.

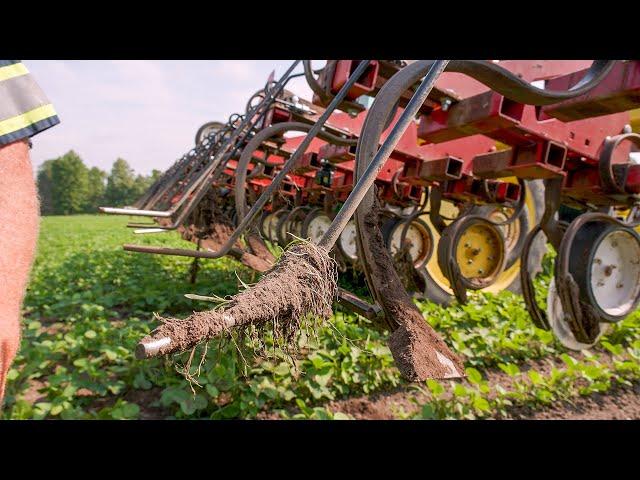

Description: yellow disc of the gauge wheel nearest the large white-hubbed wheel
[456,223,505,283]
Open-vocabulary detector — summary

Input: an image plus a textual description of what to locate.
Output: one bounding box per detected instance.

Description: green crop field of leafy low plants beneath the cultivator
[0,216,640,419]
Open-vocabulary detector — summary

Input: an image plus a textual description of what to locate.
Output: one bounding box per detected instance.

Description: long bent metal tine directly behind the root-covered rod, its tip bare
[124,60,371,259]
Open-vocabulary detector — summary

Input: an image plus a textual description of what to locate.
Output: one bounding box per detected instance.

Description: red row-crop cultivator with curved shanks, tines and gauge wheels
[101,60,640,380]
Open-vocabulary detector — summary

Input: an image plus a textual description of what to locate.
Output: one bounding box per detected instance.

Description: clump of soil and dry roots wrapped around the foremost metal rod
[138,242,337,355]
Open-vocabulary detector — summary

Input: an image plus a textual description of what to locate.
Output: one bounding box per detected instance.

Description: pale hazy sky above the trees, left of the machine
[24,60,322,174]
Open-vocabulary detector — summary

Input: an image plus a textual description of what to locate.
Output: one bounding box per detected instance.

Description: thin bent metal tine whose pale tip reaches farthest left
[100,60,300,219]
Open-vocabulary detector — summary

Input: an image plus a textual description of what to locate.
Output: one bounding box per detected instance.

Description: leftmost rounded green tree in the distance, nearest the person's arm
[51,150,89,215]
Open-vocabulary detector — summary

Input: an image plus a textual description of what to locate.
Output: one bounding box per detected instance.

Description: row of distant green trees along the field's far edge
[37,150,162,215]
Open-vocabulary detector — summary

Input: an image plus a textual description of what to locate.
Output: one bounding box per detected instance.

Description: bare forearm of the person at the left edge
[0,141,39,405]
